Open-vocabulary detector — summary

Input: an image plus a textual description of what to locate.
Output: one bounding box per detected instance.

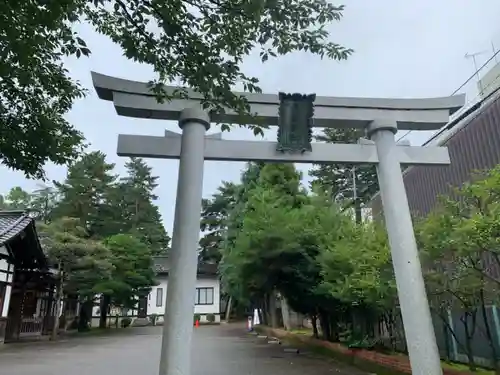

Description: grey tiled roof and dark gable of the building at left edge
[0,211,47,269]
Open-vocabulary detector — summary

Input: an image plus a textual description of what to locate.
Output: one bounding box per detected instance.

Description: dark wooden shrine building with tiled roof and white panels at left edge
[0,211,55,343]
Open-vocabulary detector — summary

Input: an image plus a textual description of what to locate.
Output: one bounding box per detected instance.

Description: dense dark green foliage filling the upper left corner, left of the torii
[0,0,90,178]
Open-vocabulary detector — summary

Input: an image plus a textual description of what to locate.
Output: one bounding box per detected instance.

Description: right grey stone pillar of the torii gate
[367,121,443,375]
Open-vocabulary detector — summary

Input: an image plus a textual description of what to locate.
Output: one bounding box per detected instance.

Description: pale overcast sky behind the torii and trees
[0,0,500,233]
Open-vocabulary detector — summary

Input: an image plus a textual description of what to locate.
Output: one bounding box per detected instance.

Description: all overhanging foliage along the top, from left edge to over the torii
[0,0,352,178]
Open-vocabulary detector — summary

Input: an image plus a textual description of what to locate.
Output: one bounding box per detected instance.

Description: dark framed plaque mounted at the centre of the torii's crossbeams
[276,92,316,153]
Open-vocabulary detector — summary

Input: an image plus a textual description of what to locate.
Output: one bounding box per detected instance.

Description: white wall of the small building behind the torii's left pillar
[148,277,220,322]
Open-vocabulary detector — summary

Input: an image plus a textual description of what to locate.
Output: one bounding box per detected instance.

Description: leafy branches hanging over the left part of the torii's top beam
[85,0,352,133]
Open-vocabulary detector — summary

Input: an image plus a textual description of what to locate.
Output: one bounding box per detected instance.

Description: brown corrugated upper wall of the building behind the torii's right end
[369,81,500,219]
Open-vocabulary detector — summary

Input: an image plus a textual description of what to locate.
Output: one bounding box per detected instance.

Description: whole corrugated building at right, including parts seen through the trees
[369,71,500,365]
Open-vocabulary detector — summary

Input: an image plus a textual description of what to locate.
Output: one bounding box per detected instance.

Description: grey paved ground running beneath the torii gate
[0,324,365,375]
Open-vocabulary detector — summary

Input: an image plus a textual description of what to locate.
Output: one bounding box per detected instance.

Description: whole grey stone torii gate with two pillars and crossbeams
[92,72,465,375]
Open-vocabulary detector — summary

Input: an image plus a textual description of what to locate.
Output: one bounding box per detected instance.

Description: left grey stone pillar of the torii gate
[159,108,210,375]
